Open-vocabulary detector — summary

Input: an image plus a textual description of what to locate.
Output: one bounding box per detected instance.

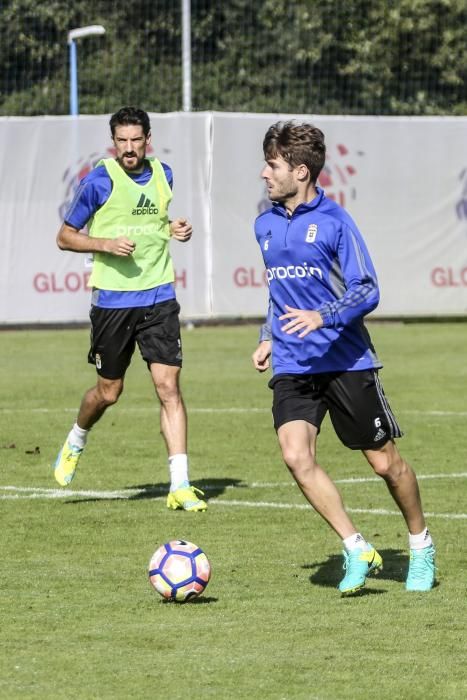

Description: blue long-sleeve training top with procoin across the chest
[255,188,382,375]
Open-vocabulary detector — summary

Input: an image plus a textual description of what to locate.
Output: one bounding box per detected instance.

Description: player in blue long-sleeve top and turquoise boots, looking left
[253,121,435,595]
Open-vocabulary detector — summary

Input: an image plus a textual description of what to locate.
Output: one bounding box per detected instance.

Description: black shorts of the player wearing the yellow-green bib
[88,299,182,379]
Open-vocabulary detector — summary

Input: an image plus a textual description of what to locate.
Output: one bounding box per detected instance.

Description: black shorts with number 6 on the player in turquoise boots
[269,369,402,450]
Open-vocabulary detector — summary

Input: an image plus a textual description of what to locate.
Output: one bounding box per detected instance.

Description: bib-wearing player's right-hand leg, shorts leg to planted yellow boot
[136,299,207,511]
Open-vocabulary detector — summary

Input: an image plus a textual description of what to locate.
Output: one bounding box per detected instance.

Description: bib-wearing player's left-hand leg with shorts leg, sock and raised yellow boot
[54,307,135,486]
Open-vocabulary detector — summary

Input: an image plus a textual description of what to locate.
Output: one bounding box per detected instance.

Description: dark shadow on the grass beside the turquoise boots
[302,549,408,595]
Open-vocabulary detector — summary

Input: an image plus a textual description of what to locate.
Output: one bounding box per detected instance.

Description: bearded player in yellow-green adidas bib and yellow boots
[54,107,207,511]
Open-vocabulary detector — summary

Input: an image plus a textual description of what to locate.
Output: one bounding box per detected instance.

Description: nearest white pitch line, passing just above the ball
[0,486,467,520]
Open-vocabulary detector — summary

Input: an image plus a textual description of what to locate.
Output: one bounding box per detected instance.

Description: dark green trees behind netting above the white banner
[0,0,467,114]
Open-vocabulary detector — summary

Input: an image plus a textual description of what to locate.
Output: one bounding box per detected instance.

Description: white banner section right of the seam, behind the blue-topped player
[212,114,467,316]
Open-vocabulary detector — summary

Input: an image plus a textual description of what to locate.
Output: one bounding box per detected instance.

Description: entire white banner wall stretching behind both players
[0,113,467,324]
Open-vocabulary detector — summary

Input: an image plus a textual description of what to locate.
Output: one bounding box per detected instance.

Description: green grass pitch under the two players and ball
[0,323,467,700]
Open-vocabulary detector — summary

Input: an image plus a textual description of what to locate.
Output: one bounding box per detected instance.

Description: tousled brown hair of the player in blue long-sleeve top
[263,121,326,184]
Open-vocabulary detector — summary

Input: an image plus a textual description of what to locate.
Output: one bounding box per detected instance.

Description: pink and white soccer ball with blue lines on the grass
[149,540,211,603]
